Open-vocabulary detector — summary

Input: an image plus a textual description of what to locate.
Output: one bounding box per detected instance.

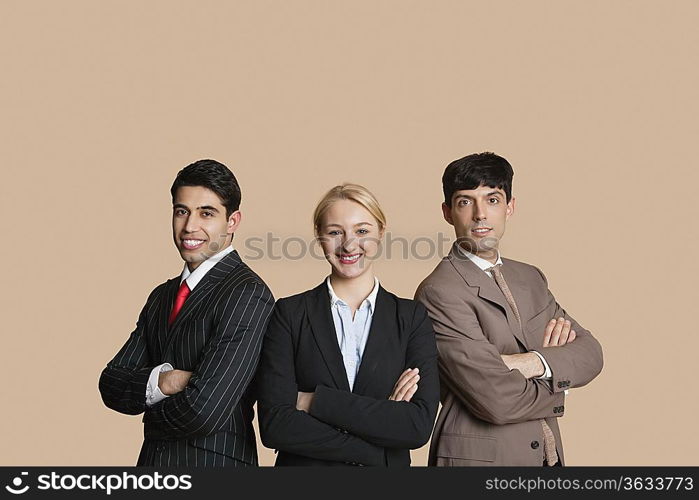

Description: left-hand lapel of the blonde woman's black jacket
[305,281,350,392]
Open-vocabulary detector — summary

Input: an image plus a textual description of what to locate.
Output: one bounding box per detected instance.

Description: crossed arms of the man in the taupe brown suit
[416,278,601,425]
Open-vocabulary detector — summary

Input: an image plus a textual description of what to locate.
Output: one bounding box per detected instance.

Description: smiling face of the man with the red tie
[172,186,240,271]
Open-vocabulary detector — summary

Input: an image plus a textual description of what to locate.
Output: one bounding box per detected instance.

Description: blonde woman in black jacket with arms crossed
[257,184,439,466]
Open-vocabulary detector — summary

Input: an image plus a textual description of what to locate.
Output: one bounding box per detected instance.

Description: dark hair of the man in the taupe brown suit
[442,153,514,206]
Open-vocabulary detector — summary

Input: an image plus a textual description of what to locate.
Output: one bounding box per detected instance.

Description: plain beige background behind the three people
[0,0,699,465]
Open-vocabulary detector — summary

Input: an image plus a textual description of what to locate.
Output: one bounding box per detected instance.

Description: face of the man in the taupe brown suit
[442,185,515,263]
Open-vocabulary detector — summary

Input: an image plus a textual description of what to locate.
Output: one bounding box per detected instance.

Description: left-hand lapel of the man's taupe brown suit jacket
[447,243,526,348]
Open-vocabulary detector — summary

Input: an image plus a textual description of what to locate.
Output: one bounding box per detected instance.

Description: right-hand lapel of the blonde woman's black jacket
[352,286,397,394]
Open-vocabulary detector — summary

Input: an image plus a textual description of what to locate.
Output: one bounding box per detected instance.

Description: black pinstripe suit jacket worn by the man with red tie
[99,251,274,466]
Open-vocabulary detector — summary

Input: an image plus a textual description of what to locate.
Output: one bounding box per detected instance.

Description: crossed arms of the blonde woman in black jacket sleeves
[258,303,439,465]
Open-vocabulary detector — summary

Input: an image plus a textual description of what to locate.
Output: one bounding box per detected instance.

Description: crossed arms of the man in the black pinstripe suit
[100,282,274,439]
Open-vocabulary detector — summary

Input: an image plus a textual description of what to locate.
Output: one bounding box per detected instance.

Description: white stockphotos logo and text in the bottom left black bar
[5,472,192,495]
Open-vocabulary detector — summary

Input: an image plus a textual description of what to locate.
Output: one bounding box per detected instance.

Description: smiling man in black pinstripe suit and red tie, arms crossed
[99,160,274,466]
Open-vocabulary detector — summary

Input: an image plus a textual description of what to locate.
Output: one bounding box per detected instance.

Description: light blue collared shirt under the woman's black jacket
[325,276,379,390]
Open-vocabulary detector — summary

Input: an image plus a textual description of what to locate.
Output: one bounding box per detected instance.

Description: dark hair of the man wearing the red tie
[170,160,240,218]
